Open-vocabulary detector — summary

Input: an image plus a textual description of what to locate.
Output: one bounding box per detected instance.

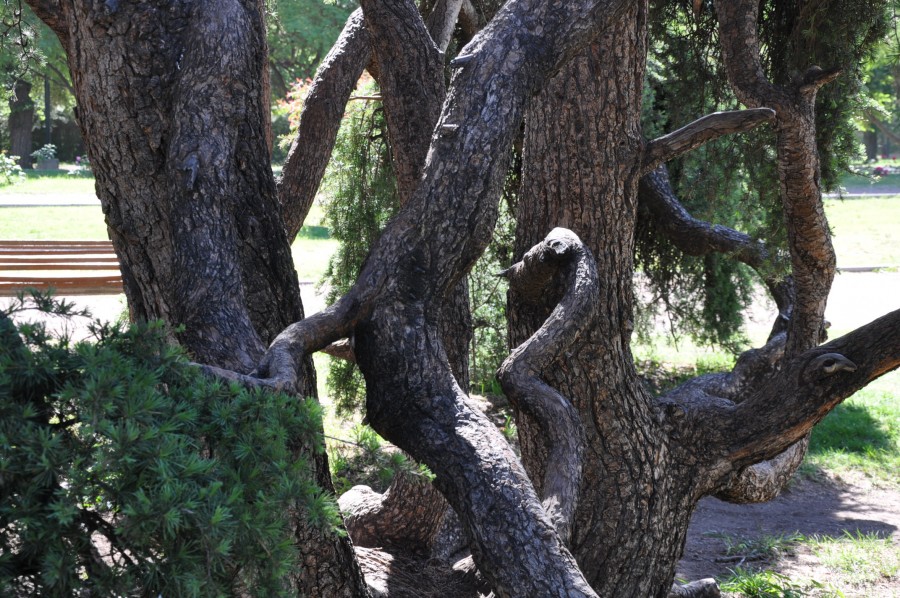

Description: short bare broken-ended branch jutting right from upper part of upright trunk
[641,108,775,174]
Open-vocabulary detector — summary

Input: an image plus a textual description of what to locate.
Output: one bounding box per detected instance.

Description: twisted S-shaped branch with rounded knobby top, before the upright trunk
[497,228,600,542]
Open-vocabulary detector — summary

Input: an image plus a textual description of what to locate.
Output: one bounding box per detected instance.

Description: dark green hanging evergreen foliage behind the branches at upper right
[637,0,887,350]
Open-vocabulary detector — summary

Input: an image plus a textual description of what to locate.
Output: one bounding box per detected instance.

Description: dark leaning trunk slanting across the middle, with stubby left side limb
[250,0,628,596]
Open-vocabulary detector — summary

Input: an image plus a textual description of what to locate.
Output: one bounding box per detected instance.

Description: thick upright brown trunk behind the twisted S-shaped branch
[509,3,693,597]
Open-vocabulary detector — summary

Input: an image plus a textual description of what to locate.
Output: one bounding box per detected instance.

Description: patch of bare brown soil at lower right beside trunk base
[677,472,900,598]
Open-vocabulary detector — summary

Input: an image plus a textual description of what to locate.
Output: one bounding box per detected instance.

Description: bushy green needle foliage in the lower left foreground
[0,295,339,596]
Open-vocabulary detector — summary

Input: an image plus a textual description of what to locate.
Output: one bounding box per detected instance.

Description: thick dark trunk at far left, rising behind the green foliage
[29,0,366,596]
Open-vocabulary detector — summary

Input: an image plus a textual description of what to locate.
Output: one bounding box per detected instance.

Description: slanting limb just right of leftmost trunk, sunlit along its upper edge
[278,9,372,239]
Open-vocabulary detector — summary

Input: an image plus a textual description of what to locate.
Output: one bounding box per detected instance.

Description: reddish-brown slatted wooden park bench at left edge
[0,241,122,297]
